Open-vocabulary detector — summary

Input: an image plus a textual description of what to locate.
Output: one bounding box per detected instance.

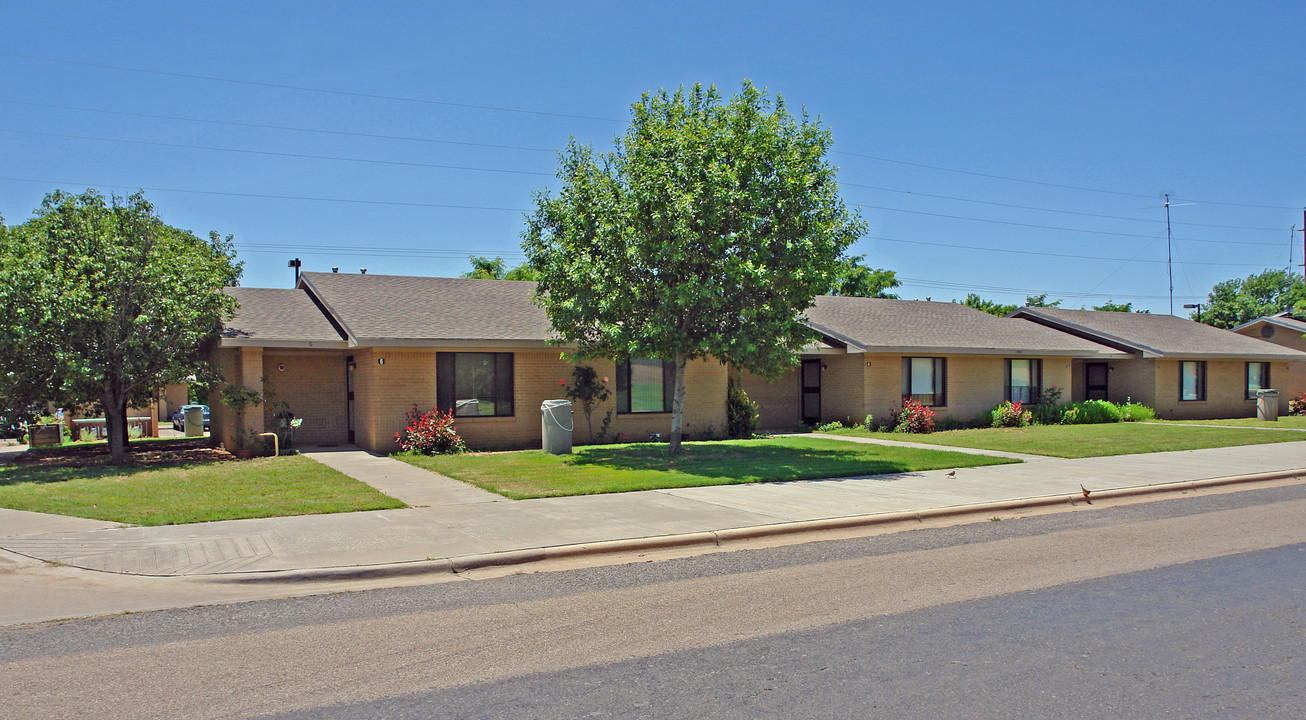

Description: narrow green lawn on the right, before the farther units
[833,422,1306,457]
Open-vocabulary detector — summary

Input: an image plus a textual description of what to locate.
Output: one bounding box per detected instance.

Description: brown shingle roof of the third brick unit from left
[1012,307,1306,359]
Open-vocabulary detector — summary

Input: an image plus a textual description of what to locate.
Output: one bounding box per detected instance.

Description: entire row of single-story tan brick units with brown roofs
[212,273,1306,452]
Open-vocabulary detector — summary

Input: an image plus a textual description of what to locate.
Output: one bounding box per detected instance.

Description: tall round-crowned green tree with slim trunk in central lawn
[524,81,865,452]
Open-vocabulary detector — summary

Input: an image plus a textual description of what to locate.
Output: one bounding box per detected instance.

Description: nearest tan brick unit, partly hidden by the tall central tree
[213,273,726,452]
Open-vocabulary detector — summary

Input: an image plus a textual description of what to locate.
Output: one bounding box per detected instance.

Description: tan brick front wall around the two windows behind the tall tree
[355,346,726,452]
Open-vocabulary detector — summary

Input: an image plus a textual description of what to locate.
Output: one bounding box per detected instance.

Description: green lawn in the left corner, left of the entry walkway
[0,456,405,525]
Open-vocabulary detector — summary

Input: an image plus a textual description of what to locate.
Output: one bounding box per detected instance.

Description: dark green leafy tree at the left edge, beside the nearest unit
[0,189,242,461]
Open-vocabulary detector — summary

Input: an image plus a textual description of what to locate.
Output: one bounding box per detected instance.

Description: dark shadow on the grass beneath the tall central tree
[563,443,929,480]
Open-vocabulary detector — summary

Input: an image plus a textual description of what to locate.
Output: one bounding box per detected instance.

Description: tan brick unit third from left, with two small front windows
[1010,307,1306,419]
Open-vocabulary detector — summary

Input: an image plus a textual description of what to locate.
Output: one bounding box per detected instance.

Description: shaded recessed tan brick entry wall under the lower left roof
[263,349,347,446]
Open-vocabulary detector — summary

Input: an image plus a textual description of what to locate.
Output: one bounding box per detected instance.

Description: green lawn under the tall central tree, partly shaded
[396,438,1011,499]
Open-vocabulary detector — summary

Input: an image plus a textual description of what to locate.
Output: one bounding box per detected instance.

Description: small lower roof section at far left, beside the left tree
[222,287,345,345]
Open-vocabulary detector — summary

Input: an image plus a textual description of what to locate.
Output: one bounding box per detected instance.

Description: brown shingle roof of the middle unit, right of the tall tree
[806,295,1119,357]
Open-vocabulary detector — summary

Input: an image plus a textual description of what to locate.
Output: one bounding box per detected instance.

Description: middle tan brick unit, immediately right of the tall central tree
[742,297,1126,429]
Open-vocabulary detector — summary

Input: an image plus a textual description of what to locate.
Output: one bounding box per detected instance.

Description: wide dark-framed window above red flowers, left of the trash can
[435,353,512,417]
